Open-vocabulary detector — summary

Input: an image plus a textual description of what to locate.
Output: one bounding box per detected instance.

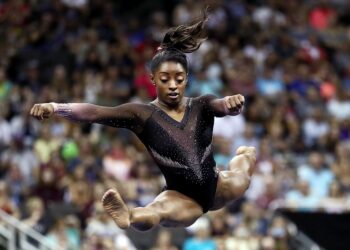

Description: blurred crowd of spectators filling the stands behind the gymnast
[0,0,350,250]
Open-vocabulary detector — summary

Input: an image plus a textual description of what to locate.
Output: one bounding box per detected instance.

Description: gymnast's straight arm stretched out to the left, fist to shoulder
[30,103,143,130]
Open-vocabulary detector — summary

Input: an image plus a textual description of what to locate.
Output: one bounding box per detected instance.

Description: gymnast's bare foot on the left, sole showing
[102,189,130,229]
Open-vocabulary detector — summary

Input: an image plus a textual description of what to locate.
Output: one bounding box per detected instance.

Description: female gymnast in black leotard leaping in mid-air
[30,14,256,231]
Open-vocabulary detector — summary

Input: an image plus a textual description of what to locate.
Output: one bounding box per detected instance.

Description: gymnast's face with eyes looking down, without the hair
[151,61,187,106]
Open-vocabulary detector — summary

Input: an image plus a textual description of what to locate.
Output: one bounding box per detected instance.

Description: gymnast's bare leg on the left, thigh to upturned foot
[102,189,203,231]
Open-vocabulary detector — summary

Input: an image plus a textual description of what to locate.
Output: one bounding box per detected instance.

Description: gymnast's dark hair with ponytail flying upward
[150,10,208,72]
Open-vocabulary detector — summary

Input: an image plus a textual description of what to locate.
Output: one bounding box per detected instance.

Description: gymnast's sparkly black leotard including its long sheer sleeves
[56,95,239,212]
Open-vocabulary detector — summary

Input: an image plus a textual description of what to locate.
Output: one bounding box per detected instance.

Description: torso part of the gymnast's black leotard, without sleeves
[138,98,218,212]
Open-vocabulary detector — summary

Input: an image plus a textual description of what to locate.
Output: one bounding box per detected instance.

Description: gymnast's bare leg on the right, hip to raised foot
[210,146,256,210]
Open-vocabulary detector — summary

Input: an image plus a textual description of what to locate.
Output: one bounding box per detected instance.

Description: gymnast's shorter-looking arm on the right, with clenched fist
[207,94,244,117]
